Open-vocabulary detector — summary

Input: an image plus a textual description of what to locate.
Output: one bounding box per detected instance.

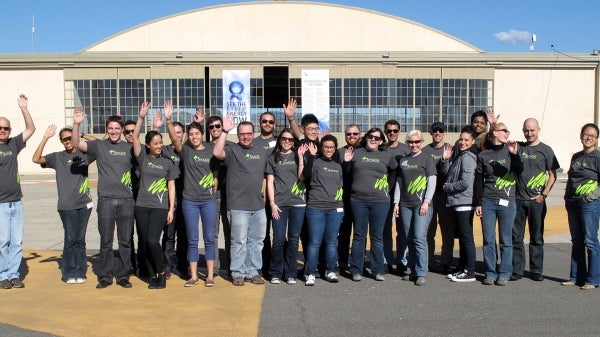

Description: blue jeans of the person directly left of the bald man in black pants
[481,198,517,279]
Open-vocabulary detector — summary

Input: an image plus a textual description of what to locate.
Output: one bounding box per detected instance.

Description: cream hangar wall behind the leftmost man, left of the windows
[0,70,65,174]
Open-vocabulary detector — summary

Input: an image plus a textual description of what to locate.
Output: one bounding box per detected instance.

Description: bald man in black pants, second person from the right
[510,118,560,281]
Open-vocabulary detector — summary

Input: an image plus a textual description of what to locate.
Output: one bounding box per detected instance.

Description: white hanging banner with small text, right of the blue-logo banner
[302,69,331,133]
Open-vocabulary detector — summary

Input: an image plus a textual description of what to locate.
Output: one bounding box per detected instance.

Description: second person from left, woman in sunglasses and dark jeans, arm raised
[33,124,95,284]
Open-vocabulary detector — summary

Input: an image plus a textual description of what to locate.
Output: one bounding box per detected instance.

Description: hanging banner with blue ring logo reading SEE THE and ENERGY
[223,70,250,134]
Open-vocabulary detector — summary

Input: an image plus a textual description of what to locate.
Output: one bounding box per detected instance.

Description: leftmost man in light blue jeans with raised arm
[0,94,35,289]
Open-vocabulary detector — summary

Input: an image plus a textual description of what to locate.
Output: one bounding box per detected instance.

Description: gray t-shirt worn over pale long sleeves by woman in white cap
[398,152,437,207]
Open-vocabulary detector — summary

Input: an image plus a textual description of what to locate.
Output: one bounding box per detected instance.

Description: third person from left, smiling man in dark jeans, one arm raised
[71,107,135,289]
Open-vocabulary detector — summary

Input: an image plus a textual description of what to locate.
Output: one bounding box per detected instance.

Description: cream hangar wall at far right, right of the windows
[494,69,596,170]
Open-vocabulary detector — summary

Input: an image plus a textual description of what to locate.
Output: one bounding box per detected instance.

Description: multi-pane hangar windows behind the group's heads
[65,78,493,134]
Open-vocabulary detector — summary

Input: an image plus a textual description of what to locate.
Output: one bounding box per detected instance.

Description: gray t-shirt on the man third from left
[87,140,134,199]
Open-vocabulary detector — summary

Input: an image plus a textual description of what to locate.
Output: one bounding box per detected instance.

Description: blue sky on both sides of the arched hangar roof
[0,0,600,53]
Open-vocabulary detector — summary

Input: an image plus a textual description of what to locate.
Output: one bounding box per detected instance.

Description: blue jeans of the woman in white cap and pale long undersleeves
[400,205,432,277]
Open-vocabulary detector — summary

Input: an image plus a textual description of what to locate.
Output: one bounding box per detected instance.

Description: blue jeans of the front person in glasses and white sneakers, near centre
[306,207,344,275]
